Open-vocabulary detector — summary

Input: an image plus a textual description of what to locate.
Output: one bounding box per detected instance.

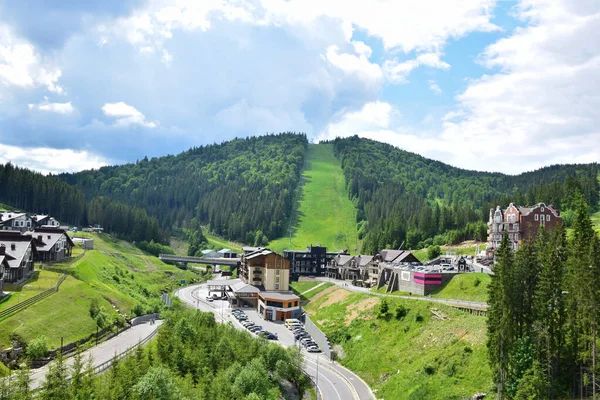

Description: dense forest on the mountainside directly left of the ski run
[59,133,308,245]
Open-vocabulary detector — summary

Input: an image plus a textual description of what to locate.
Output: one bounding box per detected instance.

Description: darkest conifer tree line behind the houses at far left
[0,163,169,243]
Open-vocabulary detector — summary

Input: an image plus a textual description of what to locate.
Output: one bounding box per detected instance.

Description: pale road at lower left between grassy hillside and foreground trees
[31,321,162,389]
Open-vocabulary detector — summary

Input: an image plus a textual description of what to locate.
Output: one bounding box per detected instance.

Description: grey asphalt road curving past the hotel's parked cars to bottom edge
[176,284,375,400]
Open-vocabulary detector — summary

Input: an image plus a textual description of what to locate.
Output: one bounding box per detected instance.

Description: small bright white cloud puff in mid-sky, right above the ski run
[325,42,383,84]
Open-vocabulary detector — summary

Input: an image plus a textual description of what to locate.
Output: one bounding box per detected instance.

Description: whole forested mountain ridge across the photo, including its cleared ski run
[0,133,599,253]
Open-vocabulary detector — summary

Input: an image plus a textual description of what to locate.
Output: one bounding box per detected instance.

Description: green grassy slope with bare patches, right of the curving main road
[305,288,492,400]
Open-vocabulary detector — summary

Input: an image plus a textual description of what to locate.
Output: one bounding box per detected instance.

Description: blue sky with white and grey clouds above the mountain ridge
[0,0,600,174]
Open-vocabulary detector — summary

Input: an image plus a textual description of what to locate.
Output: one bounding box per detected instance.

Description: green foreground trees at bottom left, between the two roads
[0,305,311,400]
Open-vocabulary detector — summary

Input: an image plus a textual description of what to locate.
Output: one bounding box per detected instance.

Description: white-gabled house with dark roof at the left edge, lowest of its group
[0,231,36,283]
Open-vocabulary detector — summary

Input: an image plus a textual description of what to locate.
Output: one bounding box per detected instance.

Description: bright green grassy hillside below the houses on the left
[0,233,195,348]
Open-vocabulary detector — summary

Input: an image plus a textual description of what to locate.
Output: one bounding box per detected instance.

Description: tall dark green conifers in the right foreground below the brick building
[487,196,600,400]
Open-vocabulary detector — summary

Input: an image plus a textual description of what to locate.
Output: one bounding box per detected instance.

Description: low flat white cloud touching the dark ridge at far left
[0,144,108,174]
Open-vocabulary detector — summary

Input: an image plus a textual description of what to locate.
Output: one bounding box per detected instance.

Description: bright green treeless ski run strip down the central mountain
[269,144,360,252]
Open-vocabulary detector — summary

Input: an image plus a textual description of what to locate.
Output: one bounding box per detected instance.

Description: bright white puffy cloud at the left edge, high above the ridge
[0,25,64,94]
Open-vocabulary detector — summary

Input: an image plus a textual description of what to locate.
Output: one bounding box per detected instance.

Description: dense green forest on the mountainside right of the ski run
[332,136,599,254]
